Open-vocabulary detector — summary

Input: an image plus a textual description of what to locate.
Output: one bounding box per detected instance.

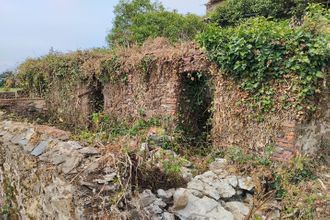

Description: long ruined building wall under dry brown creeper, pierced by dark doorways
[15,38,329,157]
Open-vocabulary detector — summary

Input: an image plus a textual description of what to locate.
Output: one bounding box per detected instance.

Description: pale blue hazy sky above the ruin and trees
[0,0,207,73]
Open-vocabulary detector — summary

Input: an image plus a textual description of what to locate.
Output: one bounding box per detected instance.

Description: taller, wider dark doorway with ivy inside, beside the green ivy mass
[179,72,213,147]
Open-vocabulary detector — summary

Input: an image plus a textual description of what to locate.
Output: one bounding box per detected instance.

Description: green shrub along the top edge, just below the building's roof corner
[210,0,322,26]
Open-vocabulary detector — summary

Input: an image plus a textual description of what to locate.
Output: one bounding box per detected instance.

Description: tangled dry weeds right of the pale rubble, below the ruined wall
[209,145,329,219]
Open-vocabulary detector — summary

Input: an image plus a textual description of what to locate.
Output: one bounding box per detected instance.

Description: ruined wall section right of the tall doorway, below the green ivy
[211,67,330,156]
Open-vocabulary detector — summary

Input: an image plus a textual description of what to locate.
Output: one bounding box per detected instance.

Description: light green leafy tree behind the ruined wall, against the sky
[107,0,204,47]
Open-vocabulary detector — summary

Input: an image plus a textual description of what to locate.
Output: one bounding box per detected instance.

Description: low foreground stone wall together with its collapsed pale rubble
[0,112,262,220]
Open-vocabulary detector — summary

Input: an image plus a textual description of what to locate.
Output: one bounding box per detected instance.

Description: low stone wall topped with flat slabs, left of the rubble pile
[0,112,116,219]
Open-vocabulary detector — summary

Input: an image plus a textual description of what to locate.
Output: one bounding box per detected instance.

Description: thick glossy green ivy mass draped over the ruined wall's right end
[199,6,330,111]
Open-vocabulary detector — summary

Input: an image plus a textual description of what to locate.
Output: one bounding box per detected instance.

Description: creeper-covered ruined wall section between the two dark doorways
[103,42,210,122]
